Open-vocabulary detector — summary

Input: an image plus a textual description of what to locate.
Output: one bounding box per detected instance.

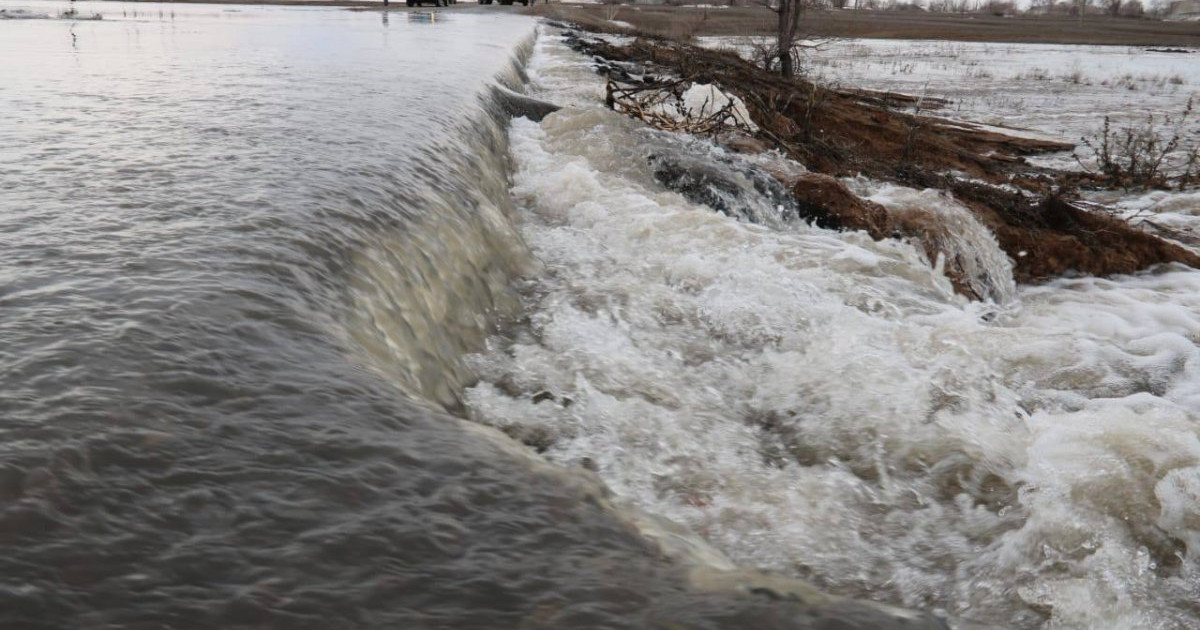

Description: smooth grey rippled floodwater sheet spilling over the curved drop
[0,2,940,630]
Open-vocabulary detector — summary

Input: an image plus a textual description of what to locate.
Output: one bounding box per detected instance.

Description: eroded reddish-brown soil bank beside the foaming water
[556,28,1200,298]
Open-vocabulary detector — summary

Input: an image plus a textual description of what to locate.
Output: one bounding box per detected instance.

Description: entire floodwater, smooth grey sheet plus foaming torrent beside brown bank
[0,1,1200,629]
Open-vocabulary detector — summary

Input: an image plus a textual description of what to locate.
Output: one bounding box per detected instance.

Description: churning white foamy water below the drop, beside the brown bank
[466,32,1200,630]
